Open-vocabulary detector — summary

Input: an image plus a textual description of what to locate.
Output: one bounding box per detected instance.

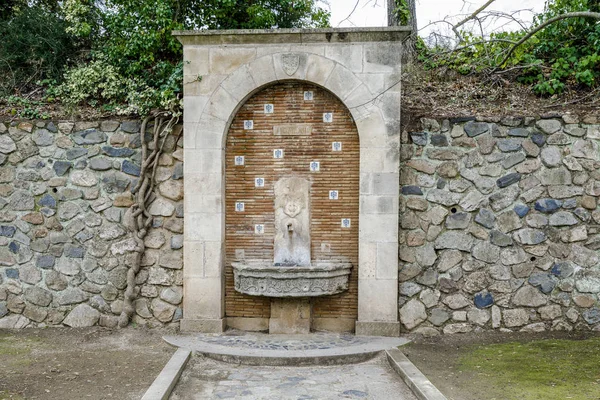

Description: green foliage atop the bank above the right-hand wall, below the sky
[418,0,600,96]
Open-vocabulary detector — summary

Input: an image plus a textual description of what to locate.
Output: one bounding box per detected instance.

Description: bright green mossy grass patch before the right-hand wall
[459,338,600,400]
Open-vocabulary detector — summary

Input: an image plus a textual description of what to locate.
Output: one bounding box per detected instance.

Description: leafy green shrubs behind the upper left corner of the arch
[53,0,329,113]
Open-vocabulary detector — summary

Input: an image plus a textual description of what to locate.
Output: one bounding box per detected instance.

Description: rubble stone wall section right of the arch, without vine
[399,115,600,335]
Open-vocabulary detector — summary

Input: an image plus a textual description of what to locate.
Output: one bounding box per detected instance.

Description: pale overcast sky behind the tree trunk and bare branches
[328,0,544,36]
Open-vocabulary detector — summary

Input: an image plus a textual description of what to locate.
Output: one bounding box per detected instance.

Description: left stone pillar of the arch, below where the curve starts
[180,139,225,333]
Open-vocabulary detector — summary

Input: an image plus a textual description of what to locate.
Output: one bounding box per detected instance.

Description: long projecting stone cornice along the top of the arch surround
[172,26,411,45]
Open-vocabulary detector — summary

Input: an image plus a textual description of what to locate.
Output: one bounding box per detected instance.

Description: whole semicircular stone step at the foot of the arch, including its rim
[163,331,409,366]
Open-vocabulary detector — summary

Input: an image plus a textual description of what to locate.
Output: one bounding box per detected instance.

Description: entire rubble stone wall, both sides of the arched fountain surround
[0,110,600,334]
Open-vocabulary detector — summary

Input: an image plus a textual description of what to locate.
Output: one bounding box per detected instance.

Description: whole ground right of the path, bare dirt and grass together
[400,332,600,400]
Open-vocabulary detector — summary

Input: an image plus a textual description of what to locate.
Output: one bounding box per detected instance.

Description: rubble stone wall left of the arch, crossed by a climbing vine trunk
[0,121,183,328]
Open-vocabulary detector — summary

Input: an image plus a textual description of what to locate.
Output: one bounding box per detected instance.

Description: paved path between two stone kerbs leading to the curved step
[170,356,416,400]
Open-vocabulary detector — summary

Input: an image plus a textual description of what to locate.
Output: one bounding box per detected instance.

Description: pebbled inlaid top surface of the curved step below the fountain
[197,331,370,350]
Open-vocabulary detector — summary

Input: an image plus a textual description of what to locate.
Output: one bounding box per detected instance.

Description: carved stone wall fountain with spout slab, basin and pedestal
[232,176,352,333]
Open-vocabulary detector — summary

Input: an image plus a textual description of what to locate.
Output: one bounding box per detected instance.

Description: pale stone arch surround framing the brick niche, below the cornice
[181,31,401,336]
